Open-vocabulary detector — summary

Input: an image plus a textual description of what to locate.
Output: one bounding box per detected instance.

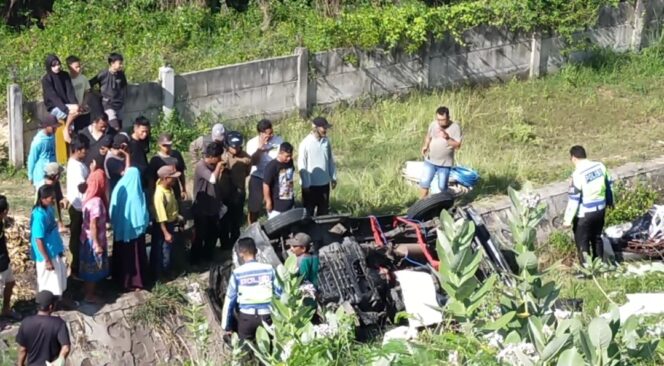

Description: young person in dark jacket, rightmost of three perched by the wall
[90,52,127,131]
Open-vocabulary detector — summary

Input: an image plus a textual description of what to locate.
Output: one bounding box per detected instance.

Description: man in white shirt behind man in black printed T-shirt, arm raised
[247,119,284,224]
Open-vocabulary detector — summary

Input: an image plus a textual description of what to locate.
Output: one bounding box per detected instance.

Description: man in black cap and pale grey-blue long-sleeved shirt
[297,117,337,216]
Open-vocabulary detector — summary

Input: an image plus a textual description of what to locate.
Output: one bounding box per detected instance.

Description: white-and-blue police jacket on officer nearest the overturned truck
[221,260,281,330]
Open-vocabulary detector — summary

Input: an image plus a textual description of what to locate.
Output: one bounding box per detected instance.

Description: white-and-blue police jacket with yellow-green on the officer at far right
[564,159,613,225]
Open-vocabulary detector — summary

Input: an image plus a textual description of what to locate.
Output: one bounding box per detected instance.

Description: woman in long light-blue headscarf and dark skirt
[111,167,149,291]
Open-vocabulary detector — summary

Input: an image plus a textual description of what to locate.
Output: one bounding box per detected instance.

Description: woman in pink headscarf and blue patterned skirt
[79,169,109,303]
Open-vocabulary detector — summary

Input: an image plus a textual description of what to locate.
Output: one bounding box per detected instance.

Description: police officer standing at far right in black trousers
[564,145,613,263]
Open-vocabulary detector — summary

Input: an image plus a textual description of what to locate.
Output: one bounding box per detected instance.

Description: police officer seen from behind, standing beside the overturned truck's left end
[221,238,281,340]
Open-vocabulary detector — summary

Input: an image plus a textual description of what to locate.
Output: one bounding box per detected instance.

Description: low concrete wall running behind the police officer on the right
[471,156,664,244]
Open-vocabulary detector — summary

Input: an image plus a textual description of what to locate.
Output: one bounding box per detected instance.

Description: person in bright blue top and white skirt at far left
[30,185,67,296]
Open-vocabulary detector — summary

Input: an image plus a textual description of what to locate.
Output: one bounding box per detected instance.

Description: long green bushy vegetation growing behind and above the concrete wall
[0,0,617,104]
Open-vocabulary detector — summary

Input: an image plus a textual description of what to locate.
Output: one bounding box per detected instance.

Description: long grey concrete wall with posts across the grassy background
[8,0,664,163]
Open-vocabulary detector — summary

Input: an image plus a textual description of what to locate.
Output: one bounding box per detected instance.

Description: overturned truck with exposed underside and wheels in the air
[208,192,510,334]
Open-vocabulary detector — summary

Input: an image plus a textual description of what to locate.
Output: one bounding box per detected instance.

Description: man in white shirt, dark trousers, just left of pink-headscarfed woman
[66,136,90,276]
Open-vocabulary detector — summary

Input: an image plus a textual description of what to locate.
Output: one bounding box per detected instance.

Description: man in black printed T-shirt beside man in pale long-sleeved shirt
[263,142,295,219]
